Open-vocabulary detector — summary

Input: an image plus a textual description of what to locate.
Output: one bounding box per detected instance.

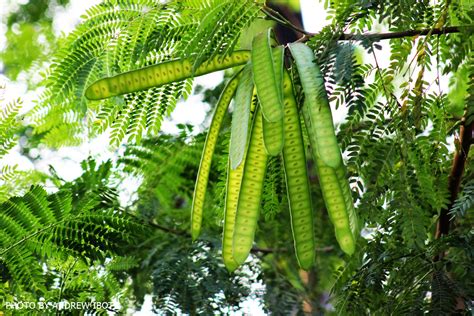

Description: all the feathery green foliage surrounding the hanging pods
[0,0,474,315]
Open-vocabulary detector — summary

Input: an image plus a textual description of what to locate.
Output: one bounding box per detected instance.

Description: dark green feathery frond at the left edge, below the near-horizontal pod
[0,161,147,295]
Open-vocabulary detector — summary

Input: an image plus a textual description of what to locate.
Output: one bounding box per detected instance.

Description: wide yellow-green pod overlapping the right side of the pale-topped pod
[232,107,268,265]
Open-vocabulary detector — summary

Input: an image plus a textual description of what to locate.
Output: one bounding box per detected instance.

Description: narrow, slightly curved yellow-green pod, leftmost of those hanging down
[191,73,240,240]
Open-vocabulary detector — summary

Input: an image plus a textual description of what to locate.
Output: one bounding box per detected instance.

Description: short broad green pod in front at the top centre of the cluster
[251,29,283,122]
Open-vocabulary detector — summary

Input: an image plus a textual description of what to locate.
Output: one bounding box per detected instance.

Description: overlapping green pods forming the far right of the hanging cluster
[289,43,358,255]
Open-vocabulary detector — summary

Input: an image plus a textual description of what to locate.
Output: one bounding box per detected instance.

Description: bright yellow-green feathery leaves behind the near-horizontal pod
[31,0,262,146]
